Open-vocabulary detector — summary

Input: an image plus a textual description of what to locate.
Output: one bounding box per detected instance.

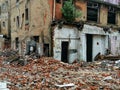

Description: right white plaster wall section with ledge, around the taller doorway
[81,25,109,61]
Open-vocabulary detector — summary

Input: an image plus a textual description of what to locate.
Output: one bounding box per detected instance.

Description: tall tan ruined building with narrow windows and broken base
[11,0,51,56]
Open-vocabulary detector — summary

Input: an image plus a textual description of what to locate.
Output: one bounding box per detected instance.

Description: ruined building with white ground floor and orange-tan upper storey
[51,0,120,63]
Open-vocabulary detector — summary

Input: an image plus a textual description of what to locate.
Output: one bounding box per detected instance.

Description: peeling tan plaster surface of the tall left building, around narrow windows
[11,0,52,52]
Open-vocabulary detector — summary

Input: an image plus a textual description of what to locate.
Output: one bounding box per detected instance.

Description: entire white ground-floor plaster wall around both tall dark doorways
[53,25,108,63]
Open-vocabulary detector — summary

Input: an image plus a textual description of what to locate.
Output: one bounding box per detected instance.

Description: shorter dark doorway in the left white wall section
[61,41,69,63]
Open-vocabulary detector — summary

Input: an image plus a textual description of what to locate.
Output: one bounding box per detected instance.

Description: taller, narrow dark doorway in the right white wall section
[86,34,93,62]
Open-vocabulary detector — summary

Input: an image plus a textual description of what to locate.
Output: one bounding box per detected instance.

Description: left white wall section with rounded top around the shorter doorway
[53,26,80,63]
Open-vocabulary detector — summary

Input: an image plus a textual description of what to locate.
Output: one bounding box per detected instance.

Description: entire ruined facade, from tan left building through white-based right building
[1,0,120,63]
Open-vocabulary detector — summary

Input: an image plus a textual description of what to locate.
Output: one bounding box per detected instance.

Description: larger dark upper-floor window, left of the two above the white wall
[87,2,99,22]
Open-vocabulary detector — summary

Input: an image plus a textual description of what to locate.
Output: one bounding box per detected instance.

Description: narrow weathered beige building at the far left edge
[0,0,10,50]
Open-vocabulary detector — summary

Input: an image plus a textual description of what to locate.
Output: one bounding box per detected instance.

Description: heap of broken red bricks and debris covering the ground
[0,57,120,90]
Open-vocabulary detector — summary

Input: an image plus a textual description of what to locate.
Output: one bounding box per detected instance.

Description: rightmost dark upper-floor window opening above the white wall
[107,7,116,24]
